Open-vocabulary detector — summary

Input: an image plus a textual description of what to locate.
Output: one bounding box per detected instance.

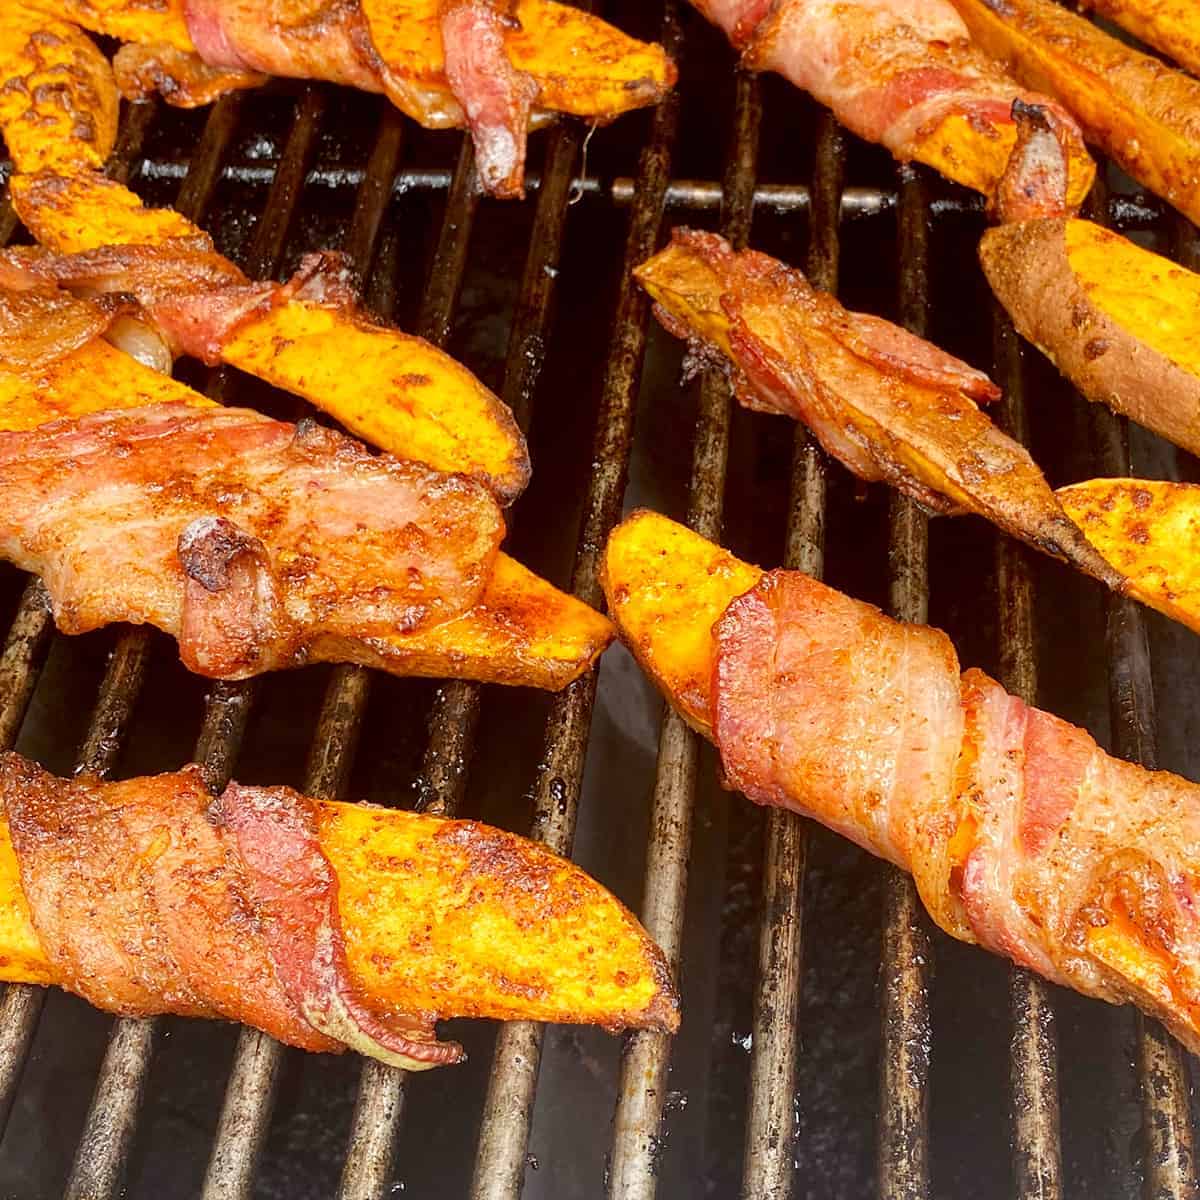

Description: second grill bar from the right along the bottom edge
[994,306,1062,1200]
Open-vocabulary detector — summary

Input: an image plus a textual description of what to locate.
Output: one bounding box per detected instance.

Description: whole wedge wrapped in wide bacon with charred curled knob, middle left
[0,314,612,690]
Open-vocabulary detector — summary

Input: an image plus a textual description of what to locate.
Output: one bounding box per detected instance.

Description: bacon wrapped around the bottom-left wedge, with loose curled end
[0,752,463,1069]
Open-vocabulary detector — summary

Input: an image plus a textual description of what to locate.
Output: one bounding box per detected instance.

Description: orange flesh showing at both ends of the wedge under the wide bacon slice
[0,338,613,691]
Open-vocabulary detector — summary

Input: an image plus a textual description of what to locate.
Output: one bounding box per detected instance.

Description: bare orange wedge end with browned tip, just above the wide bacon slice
[222,300,529,504]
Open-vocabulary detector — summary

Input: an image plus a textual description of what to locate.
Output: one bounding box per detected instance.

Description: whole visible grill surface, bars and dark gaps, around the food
[0,0,1200,1200]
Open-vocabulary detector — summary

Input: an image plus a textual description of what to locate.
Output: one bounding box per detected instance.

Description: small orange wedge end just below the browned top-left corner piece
[8,170,208,254]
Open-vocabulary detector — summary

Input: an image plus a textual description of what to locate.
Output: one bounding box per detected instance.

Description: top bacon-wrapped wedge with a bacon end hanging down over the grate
[9,0,676,197]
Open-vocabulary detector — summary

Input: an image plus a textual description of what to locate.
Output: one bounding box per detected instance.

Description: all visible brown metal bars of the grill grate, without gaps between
[0,0,1200,1200]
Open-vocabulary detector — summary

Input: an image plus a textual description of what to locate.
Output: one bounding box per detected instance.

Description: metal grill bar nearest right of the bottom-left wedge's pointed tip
[742,105,846,1200]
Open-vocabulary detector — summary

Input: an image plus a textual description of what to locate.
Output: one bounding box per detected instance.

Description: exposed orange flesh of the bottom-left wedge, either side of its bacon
[0,787,679,1031]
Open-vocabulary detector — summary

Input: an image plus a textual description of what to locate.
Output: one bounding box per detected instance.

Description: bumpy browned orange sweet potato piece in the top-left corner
[0,7,118,172]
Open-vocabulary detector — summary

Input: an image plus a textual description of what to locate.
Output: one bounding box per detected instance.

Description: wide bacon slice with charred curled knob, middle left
[0,403,504,678]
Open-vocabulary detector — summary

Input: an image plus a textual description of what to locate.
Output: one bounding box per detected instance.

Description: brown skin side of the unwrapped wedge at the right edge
[979,217,1200,454]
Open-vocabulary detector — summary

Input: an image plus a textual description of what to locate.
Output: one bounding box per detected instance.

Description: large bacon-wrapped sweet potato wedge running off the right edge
[604,512,1200,1052]
